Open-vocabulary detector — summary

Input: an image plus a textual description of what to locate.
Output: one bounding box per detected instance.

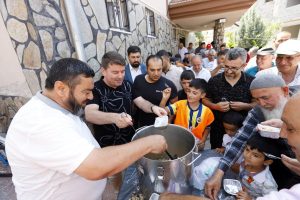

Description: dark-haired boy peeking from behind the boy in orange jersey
[178,70,195,100]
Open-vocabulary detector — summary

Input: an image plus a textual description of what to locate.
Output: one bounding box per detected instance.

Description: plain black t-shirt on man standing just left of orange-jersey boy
[132,74,177,127]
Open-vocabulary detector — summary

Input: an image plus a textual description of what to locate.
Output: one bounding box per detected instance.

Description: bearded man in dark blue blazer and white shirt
[125,46,146,84]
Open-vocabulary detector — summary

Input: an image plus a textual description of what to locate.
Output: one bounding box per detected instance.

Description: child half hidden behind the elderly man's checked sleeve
[216,111,244,154]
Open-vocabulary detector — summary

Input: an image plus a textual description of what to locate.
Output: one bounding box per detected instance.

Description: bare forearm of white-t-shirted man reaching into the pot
[75,135,167,180]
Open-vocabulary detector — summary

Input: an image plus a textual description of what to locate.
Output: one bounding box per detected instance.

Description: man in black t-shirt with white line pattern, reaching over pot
[85,52,166,147]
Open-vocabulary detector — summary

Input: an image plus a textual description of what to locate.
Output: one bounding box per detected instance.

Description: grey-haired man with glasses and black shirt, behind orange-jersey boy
[203,48,253,149]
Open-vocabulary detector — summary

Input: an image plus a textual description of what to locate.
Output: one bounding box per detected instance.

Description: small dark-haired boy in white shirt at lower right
[236,134,280,200]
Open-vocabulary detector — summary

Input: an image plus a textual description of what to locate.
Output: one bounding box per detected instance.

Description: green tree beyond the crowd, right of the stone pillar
[238,9,276,48]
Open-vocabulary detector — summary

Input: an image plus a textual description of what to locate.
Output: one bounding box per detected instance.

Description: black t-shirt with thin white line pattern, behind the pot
[88,79,134,147]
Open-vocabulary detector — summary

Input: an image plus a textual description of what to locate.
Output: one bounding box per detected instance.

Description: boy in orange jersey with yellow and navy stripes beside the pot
[163,79,214,149]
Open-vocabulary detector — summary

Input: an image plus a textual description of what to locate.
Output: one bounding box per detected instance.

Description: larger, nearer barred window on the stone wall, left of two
[106,0,129,31]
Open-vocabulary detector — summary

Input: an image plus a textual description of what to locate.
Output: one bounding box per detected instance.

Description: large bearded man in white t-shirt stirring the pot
[5,58,167,200]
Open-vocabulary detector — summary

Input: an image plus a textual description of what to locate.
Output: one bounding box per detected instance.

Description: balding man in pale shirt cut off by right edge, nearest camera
[160,81,300,200]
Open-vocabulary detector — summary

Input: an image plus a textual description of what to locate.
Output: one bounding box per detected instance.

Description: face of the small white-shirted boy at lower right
[243,145,272,172]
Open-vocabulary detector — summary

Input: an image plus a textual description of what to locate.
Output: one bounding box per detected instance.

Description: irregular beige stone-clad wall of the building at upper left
[0,0,177,132]
